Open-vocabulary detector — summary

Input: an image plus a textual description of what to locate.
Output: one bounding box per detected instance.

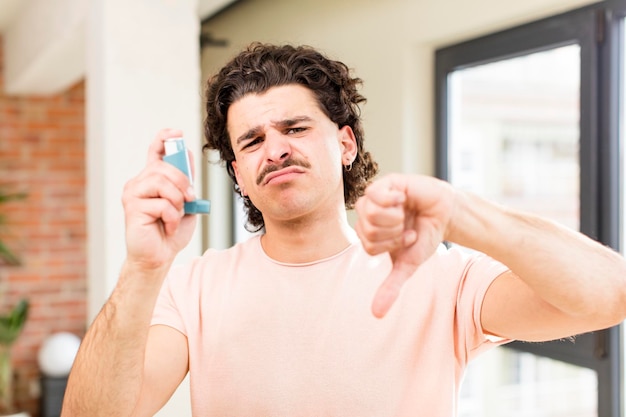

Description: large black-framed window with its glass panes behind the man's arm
[436,1,626,417]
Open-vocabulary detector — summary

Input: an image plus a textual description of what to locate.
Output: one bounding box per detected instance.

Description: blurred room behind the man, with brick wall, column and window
[0,0,626,417]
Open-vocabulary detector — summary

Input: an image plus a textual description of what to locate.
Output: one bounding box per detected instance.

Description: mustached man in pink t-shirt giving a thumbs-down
[63,44,626,417]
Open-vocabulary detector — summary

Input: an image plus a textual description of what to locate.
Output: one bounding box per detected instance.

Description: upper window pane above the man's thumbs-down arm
[448,45,580,229]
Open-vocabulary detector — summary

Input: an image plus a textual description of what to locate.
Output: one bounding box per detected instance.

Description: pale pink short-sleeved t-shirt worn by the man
[152,237,506,417]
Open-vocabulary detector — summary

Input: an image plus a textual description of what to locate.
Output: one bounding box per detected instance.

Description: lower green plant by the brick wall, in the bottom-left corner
[0,299,29,413]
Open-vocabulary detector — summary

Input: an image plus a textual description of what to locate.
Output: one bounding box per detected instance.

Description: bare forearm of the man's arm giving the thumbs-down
[448,193,626,326]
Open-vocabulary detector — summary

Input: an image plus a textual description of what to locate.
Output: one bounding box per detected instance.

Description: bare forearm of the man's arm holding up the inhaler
[62,265,165,417]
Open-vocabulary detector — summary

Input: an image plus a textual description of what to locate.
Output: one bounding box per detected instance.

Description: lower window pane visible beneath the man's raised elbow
[459,348,598,417]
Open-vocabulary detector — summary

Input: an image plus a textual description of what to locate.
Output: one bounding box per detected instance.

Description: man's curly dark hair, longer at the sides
[203,42,378,231]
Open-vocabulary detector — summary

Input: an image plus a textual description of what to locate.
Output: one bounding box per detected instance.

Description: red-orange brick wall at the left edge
[0,38,87,417]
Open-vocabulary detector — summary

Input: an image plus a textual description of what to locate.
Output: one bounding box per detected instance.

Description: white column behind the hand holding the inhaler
[86,0,202,416]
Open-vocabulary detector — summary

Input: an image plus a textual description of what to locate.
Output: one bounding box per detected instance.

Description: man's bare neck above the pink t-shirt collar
[261,209,357,263]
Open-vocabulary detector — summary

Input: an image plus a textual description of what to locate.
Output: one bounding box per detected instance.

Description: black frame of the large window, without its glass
[435,0,626,417]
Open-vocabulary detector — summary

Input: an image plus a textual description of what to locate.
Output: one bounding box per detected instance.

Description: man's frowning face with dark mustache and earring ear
[227,85,357,225]
